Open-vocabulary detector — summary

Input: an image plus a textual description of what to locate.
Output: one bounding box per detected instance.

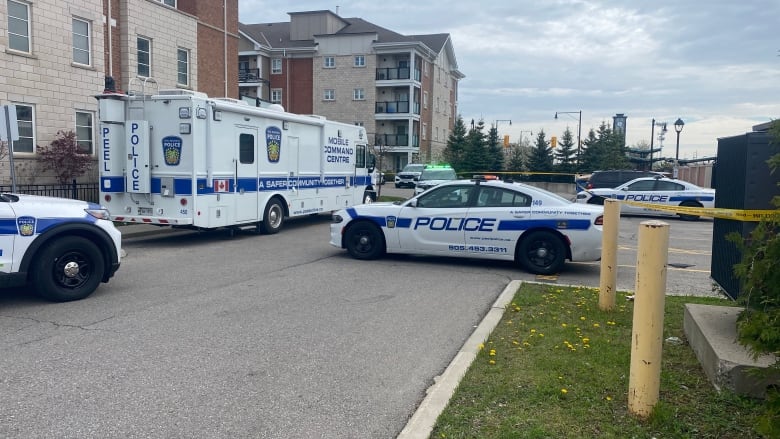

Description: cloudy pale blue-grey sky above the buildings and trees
[239,0,780,159]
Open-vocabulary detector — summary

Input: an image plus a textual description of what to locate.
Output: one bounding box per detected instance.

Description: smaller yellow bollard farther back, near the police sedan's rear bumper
[599,198,620,311]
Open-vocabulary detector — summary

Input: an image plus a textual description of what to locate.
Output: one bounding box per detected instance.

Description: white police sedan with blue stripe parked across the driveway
[330,178,603,274]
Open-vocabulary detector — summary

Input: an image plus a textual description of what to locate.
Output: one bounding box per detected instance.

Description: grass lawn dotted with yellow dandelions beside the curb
[431,283,763,439]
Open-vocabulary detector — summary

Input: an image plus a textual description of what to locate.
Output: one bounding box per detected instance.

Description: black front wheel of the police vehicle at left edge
[33,236,106,302]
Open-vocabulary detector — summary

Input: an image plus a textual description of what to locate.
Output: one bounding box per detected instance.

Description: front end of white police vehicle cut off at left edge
[0,193,122,302]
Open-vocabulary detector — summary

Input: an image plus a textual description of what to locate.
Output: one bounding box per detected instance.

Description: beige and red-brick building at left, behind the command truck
[0,0,239,184]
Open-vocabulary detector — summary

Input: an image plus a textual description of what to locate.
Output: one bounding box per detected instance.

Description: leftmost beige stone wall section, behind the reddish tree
[0,0,104,184]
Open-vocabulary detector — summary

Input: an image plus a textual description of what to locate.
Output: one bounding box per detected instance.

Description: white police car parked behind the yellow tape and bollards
[577,176,715,220]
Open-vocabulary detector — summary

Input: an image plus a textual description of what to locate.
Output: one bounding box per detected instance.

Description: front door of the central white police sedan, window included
[398,184,476,255]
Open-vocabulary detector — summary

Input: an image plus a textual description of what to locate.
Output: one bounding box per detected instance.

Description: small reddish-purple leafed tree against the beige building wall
[38,130,92,185]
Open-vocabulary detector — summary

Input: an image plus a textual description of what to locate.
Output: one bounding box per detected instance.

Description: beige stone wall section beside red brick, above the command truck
[119,0,198,91]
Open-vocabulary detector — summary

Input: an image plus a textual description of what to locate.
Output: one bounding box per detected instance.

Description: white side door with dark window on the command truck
[236,126,260,222]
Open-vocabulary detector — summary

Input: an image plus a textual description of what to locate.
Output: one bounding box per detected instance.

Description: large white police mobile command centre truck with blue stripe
[97,90,376,234]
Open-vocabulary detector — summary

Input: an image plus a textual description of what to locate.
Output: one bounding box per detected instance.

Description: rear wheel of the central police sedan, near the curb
[517,230,566,275]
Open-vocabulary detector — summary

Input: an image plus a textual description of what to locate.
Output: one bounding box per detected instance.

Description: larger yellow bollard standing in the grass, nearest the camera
[628,221,669,418]
